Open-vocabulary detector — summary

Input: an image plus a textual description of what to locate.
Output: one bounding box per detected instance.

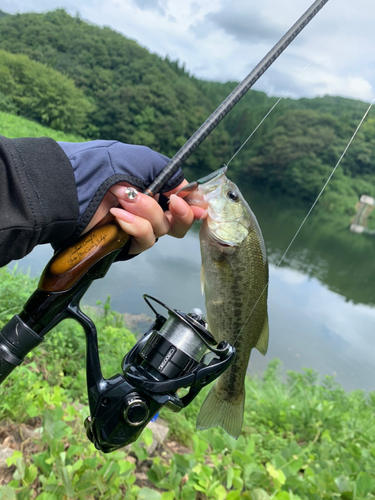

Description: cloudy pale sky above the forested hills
[0,0,375,102]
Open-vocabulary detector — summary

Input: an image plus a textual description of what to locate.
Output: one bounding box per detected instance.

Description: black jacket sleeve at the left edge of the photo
[0,136,79,267]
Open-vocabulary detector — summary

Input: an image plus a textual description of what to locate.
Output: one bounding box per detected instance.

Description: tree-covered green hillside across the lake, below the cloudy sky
[0,10,375,211]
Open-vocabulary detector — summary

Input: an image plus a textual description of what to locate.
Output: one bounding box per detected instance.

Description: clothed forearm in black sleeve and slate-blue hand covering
[0,136,185,266]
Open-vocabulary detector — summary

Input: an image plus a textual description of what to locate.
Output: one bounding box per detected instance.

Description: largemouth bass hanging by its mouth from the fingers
[178,167,268,438]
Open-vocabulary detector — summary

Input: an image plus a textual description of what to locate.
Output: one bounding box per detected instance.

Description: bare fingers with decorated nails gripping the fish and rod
[85,180,204,255]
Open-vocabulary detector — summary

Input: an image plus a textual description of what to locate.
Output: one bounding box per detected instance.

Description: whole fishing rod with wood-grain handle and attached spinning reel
[0,0,328,453]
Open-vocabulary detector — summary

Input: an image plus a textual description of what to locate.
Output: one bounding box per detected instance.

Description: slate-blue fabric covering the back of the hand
[58,141,184,237]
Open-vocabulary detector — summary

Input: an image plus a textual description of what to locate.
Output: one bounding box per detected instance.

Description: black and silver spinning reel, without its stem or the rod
[85,296,235,453]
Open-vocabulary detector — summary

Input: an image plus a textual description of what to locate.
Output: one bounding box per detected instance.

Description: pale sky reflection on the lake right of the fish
[264,266,375,390]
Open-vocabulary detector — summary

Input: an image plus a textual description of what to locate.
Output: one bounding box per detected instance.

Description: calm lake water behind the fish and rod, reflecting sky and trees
[8,184,375,390]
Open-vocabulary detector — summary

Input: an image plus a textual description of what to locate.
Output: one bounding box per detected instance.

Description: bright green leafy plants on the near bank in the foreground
[0,269,375,500]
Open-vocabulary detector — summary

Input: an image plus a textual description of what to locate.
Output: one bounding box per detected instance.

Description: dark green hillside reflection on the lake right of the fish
[245,185,375,305]
